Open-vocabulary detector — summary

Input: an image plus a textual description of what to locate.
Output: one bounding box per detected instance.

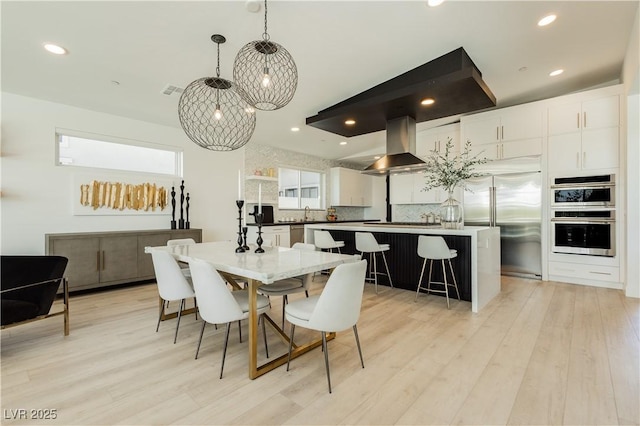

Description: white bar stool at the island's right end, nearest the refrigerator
[415,235,460,309]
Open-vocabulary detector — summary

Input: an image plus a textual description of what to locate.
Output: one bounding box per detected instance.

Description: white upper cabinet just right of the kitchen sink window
[329,167,374,207]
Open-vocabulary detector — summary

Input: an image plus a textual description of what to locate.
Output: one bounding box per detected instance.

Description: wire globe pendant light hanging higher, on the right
[233,0,298,111]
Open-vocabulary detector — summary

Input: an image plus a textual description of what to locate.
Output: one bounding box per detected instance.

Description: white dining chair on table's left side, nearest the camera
[189,260,269,379]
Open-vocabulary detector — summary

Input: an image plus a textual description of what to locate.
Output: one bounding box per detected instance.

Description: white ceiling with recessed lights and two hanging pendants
[1,0,639,163]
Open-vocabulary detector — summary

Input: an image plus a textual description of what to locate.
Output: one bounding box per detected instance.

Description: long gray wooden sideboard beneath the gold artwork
[45,229,202,291]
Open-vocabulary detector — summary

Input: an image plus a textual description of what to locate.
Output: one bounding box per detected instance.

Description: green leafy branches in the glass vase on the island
[423,138,489,192]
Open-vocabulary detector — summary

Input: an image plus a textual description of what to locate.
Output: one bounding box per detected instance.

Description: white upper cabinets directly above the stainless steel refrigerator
[460,103,544,160]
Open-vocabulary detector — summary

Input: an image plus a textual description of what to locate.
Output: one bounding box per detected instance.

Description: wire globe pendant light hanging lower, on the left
[178,34,256,151]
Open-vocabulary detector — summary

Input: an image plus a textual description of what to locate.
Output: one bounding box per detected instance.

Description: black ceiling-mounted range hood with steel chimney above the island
[306,47,496,174]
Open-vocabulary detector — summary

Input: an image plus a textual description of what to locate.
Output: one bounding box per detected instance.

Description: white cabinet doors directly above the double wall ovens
[548,95,620,172]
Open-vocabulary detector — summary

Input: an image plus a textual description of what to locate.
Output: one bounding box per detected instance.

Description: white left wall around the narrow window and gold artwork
[0,93,244,254]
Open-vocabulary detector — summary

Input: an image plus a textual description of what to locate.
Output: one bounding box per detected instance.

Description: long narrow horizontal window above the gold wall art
[56,131,182,176]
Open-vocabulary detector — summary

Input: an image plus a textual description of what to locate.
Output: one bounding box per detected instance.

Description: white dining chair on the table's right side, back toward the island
[285,256,367,393]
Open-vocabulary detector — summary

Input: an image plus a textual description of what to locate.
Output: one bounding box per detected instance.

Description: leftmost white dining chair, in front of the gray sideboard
[151,250,197,343]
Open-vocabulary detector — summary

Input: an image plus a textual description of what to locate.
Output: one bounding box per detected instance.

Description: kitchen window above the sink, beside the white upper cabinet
[278,168,325,210]
